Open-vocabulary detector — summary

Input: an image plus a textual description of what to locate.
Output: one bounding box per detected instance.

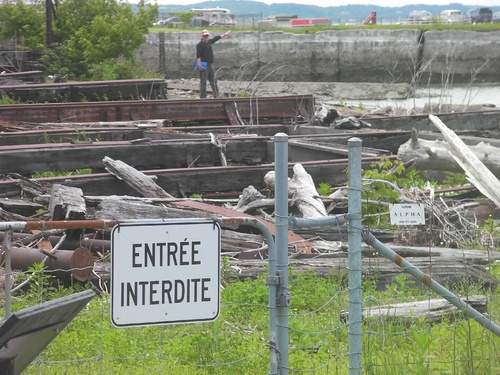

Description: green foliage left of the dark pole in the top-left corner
[0,0,45,49]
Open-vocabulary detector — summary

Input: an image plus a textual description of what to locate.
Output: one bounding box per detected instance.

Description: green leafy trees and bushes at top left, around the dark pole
[0,0,158,80]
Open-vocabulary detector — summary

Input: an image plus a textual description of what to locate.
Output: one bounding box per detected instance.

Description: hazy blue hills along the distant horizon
[155,0,500,20]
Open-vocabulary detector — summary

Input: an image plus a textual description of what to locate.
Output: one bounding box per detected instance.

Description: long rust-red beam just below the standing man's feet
[0,95,314,125]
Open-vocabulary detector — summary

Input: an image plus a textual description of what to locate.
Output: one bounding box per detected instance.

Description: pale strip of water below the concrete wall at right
[345,84,500,114]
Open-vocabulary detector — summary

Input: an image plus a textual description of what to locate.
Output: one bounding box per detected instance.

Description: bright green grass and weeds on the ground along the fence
[0,271,500,375]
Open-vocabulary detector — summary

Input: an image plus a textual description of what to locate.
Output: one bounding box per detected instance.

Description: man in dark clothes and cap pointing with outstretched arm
[196,30,231,98]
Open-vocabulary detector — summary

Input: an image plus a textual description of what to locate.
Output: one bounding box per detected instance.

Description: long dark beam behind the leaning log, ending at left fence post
[0,136,271,174]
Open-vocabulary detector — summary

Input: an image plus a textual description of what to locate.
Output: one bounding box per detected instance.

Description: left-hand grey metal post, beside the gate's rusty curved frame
[274,133,290,374]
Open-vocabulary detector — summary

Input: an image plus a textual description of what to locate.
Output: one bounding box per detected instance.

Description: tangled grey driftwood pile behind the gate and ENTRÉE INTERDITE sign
[0,114,500,320]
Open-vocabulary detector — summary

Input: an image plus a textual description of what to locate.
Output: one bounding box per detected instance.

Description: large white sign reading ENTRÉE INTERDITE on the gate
[111,220,221,327]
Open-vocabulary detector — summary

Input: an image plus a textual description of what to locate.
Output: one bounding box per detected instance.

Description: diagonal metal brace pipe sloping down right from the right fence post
[362,229,500,336]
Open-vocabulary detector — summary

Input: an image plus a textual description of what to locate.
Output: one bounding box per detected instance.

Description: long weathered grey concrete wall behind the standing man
[137,29,500,83]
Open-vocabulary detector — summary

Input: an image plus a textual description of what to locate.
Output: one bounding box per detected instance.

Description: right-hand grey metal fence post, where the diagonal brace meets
[347,138,363,375]
